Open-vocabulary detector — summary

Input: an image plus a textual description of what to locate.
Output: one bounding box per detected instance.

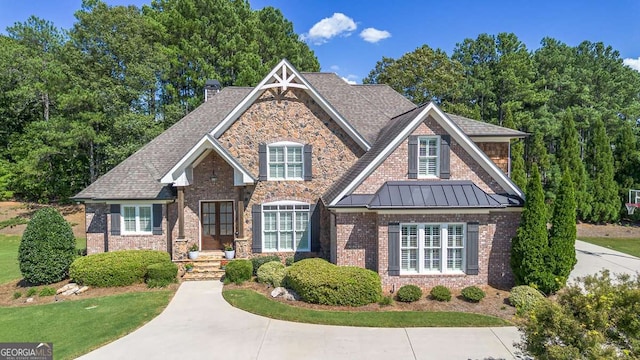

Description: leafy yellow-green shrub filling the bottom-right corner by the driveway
[518,270,640,360]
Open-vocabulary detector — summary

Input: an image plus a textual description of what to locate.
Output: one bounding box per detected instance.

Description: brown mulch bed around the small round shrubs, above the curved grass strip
[225,281,516,321]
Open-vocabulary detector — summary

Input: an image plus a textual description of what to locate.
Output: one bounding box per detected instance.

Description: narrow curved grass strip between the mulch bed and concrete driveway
[222,289,511,327]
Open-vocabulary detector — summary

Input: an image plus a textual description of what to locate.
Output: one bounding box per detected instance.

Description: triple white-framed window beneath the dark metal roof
[400,223,466,274]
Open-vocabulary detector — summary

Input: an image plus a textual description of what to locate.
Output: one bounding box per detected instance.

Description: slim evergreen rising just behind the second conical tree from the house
[556,110,591,220]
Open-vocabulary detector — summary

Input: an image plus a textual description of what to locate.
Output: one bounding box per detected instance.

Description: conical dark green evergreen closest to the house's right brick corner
[511,164,552,289]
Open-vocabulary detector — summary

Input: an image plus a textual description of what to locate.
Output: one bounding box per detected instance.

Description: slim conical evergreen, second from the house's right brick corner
[548,167,578,293]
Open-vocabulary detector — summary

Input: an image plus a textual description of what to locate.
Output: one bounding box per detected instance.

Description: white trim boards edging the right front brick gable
[329,103,524,206]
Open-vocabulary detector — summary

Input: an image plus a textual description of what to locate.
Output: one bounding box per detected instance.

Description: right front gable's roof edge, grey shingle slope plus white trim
[323,103,524,206]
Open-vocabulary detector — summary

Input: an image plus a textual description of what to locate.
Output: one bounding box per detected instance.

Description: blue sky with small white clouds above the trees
[0,0,640,83]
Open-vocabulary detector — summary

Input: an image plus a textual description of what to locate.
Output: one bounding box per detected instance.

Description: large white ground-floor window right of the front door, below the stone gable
[262,202,311,252]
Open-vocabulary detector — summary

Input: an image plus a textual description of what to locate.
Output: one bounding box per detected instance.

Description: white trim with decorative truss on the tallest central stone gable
[210,59,371,151]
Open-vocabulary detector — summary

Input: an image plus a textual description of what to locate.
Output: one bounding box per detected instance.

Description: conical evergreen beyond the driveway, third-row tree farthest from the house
[588,118,621,223]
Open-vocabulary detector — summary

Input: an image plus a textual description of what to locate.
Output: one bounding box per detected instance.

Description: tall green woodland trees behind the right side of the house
[364,33,640,223]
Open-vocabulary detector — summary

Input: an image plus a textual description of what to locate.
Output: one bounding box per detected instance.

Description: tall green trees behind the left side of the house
[0,0,320,202]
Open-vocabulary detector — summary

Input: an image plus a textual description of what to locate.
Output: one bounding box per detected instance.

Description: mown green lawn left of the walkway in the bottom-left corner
[0,290,172,359]
